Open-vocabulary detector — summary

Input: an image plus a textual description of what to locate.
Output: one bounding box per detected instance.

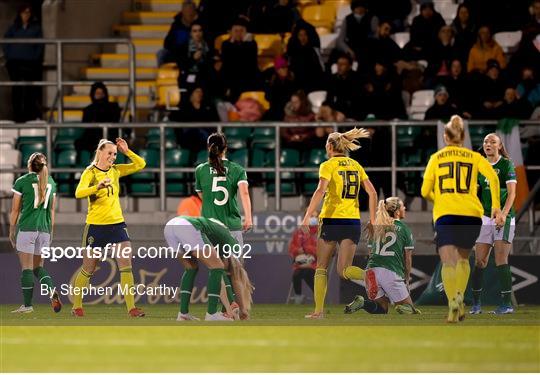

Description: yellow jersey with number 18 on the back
[319,156,368,219]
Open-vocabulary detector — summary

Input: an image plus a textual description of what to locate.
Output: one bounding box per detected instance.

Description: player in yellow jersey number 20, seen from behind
[422,116,504,323]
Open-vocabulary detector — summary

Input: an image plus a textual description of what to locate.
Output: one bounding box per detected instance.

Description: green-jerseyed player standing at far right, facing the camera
[470,133,517,314]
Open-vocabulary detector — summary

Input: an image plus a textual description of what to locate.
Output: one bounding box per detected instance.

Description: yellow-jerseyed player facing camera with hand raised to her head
[72,138,146,317]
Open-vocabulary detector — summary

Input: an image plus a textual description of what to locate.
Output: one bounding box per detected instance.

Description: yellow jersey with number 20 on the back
[422,146,501,221]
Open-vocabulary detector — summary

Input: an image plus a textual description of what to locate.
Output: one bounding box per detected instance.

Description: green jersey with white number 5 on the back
[195,159,247,231]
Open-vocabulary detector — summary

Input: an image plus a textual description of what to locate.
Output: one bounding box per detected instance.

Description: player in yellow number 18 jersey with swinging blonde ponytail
[302,128,377,319]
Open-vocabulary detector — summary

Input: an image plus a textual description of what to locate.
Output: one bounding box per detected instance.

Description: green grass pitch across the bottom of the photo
[0,305,540,372]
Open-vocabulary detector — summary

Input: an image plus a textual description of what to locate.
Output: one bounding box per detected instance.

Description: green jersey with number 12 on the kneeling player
[367,220,414,278]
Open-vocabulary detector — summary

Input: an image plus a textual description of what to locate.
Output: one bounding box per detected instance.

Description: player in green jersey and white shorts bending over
[164,216,252,321]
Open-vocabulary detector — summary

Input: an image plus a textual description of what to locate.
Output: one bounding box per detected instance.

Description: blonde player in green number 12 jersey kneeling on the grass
[345,197,420,314]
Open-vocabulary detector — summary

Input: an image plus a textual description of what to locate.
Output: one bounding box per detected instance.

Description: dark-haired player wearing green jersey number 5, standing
[194,133,253,316]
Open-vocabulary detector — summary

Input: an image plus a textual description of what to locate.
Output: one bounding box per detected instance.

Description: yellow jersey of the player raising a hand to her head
[75,150,146,225]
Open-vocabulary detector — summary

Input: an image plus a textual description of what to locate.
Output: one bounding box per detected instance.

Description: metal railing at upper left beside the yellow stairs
[0,38,137,123]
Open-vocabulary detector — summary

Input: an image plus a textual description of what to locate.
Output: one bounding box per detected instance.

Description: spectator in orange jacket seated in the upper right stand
[467,25,506,73]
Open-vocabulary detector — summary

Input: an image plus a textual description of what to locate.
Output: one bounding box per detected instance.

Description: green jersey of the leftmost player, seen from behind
[11,172,56,233]
